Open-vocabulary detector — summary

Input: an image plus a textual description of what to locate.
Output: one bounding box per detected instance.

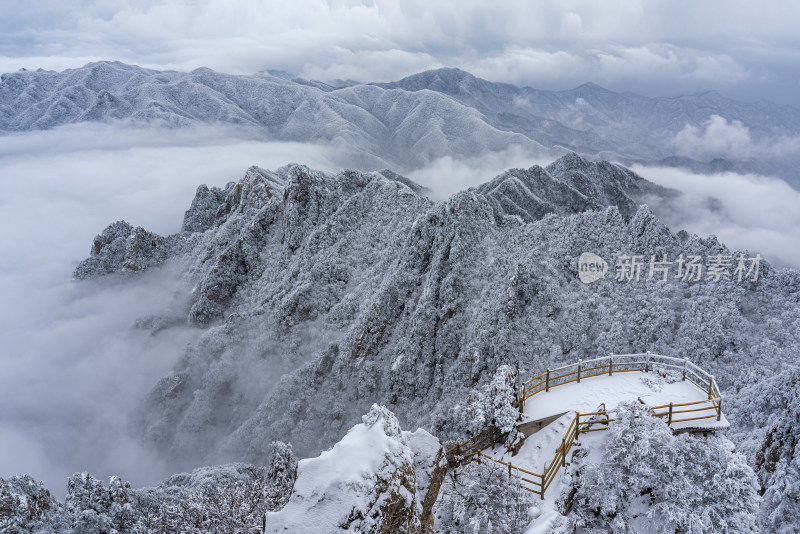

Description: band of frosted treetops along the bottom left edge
[0,450,297,534]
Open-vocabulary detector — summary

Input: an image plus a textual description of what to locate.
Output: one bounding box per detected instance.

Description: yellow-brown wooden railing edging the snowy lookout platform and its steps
[445,352,722,499]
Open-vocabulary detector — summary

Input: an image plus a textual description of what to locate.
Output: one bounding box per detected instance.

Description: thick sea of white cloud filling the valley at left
[0,124,336,493]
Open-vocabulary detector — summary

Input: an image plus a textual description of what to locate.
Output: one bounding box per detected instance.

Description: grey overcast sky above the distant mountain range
[0,0,800,106]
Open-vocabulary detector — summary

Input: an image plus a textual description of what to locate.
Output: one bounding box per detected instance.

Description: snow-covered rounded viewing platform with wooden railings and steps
[446,352,730,499]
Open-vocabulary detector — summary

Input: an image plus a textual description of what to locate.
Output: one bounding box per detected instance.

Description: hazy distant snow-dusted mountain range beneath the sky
[0,62,800,187]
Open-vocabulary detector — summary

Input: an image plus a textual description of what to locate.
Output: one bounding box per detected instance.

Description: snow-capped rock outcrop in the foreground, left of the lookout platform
[266,405,447,534]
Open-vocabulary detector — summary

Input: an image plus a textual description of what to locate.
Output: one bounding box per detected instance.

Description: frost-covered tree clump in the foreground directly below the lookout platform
[561,403,759,534]
